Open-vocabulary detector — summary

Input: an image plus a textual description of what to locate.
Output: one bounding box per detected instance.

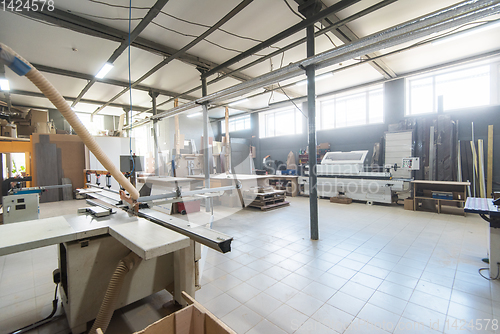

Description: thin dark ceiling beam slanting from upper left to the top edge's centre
[92,0,254,115]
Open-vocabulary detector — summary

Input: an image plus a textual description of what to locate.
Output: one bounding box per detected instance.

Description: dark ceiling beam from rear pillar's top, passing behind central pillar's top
[202,0,361,78]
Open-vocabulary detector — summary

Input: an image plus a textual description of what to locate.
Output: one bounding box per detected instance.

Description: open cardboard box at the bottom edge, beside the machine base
[135,292,236,334]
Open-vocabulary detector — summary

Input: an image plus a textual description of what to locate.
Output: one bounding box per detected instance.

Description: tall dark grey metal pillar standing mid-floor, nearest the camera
[306,18,319,240]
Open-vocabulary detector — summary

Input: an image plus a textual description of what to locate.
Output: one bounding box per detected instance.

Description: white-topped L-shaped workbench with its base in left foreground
[0,210,200,334]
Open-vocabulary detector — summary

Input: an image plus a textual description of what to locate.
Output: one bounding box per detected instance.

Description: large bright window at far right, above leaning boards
[406,60,497,116]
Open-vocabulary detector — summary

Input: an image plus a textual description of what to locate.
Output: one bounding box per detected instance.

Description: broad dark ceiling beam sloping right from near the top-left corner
[16,8,251,81]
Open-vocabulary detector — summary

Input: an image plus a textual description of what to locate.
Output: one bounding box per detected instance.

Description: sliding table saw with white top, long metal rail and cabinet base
[0,187,235,334]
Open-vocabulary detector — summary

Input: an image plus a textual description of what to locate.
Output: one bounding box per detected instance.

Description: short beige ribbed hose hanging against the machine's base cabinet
[89,252,141,334]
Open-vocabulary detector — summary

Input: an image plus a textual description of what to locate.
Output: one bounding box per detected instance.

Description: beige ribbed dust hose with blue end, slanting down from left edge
[0,43,139,200]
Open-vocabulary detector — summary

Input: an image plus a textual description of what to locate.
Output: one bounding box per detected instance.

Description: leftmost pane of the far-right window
[408,77,434,115]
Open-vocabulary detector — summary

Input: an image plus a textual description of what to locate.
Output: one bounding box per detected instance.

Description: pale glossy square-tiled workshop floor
[0,197,500,334]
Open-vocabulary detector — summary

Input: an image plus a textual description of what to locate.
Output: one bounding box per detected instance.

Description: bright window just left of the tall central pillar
[259,107,303,138]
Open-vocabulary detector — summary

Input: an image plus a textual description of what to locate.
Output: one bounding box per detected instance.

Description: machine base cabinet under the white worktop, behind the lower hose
[59,235,177,334]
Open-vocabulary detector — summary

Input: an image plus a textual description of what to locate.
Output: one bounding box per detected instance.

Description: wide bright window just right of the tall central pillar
[316,85,384,130]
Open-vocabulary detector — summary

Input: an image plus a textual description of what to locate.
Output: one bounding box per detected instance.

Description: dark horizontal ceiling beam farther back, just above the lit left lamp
[32,63,197,101]
